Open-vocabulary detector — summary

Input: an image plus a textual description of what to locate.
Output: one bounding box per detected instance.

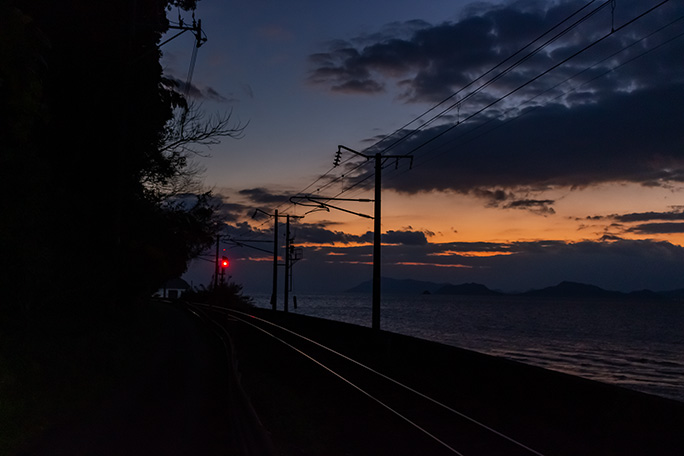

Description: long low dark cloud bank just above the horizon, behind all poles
[184,223,684,293]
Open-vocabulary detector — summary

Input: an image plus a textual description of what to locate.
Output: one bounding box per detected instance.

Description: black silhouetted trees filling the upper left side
[0,0,215,313]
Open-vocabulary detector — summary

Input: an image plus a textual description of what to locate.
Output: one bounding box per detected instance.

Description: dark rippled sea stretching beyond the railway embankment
[251,293,684,402]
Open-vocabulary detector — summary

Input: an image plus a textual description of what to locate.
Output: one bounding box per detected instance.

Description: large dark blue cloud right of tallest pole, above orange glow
[378,85,684,194]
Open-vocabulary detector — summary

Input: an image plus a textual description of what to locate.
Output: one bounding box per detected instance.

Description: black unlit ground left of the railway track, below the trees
[9,302,274,456]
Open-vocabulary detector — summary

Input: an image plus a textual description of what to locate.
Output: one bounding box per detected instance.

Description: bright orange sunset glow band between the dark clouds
[234,184,684,253]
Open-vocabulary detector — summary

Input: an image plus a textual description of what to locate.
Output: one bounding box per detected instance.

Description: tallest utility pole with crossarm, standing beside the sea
[335,146,413,330]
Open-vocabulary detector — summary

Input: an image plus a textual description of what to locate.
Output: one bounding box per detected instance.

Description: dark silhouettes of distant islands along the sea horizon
[346,277,684,301]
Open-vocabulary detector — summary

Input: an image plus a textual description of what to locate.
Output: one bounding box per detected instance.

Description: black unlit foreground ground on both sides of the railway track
[6,304,684,456]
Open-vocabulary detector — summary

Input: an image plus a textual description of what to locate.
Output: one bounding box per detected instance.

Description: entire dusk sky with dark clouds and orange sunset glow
[162,0,684,296]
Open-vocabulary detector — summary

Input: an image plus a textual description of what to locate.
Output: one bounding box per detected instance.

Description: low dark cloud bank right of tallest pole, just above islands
[383,235,684,291]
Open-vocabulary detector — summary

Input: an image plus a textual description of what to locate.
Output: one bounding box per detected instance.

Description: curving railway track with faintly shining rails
[192,307,545,456]
